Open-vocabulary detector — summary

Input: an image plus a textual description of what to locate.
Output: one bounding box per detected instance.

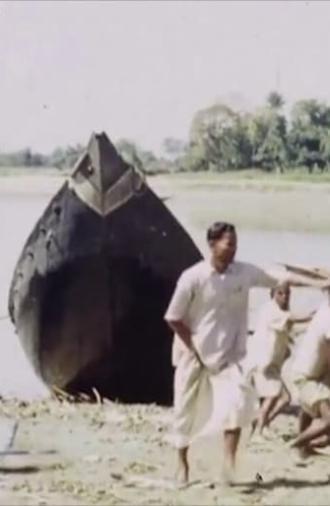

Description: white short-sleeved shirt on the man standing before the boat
[165,260,279,371]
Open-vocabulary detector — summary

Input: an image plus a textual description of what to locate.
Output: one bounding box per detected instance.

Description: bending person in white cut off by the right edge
[291,294,330,456]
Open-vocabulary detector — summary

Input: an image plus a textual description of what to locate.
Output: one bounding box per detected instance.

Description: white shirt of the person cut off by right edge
[291,301,330,380]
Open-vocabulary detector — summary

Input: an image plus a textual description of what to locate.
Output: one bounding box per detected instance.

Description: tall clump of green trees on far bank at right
[182,92,330,172]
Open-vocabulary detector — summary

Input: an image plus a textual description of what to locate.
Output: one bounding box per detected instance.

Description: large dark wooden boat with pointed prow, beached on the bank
[9,133,201,404]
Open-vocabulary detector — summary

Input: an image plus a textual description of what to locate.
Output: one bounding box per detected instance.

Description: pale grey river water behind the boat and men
[0,192,330,398]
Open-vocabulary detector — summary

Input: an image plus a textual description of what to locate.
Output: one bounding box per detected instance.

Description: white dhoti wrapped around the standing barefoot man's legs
[170,353,257,448]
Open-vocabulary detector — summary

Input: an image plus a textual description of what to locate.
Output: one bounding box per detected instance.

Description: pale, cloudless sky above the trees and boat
[0,1,330,152]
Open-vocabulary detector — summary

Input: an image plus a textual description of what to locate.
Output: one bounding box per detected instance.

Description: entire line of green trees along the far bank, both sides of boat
[0,91,330,173]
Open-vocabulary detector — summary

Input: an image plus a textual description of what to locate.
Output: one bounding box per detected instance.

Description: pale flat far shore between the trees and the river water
[0,170,330,234]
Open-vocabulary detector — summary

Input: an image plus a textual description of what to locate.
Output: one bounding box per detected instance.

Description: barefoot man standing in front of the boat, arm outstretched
[165,222,330,483]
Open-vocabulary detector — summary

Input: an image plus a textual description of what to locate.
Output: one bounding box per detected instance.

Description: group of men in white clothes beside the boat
[165,222,330,483]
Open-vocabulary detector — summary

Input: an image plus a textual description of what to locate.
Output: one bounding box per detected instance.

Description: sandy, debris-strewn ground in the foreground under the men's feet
[0,400,330,505]
